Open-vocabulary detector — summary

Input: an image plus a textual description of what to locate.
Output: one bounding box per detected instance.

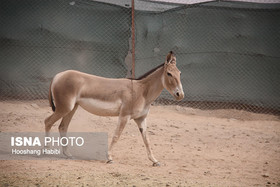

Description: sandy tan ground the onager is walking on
[0,101,280,187]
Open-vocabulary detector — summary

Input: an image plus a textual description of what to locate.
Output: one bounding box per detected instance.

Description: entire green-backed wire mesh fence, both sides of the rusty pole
[0,0,280,114]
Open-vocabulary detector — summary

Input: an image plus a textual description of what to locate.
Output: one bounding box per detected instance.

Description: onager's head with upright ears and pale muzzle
[162,51,184,101]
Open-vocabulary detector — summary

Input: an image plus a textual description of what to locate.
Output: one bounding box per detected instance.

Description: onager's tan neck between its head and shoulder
[138,66,164,104]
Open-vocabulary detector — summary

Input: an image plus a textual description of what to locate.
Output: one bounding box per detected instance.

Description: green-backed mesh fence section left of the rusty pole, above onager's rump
[0,0,131,99]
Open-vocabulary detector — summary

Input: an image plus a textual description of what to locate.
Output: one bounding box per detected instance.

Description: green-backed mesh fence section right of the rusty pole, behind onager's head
[135,2,280,114]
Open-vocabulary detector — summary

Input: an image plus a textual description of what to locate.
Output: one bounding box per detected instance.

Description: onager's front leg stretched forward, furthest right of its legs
[134,117,160,166]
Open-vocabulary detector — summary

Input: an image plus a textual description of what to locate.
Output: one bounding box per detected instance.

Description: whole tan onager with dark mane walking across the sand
[45,51,184,166]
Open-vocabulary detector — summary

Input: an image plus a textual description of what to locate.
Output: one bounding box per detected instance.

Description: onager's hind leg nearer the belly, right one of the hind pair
[58,105,78,158]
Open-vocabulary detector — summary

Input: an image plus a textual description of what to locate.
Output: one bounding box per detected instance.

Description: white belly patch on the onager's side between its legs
[78,98,121,116]
